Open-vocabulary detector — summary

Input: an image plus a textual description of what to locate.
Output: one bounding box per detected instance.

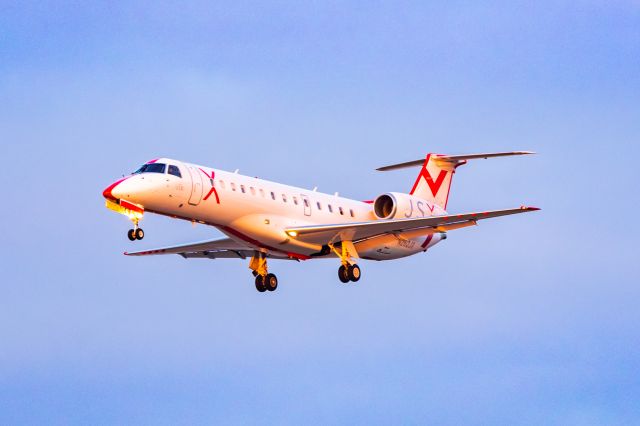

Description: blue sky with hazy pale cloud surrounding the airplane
[0,0,640,425]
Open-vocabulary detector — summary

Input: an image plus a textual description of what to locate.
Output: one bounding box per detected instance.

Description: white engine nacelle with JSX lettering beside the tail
[373,192,444,219]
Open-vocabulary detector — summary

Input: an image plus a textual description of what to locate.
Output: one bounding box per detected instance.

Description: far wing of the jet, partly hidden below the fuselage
[125,238,288,259]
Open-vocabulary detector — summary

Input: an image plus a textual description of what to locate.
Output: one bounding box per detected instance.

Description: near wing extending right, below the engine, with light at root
[285,206,540,244]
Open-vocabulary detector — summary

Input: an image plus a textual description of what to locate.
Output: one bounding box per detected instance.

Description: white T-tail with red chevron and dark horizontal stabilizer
[377,151,533,210]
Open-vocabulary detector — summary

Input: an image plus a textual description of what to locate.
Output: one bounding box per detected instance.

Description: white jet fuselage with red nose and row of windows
[104,158,446,260]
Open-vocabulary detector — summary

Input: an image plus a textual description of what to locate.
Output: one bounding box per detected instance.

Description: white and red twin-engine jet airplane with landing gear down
[103,151,539,293]
